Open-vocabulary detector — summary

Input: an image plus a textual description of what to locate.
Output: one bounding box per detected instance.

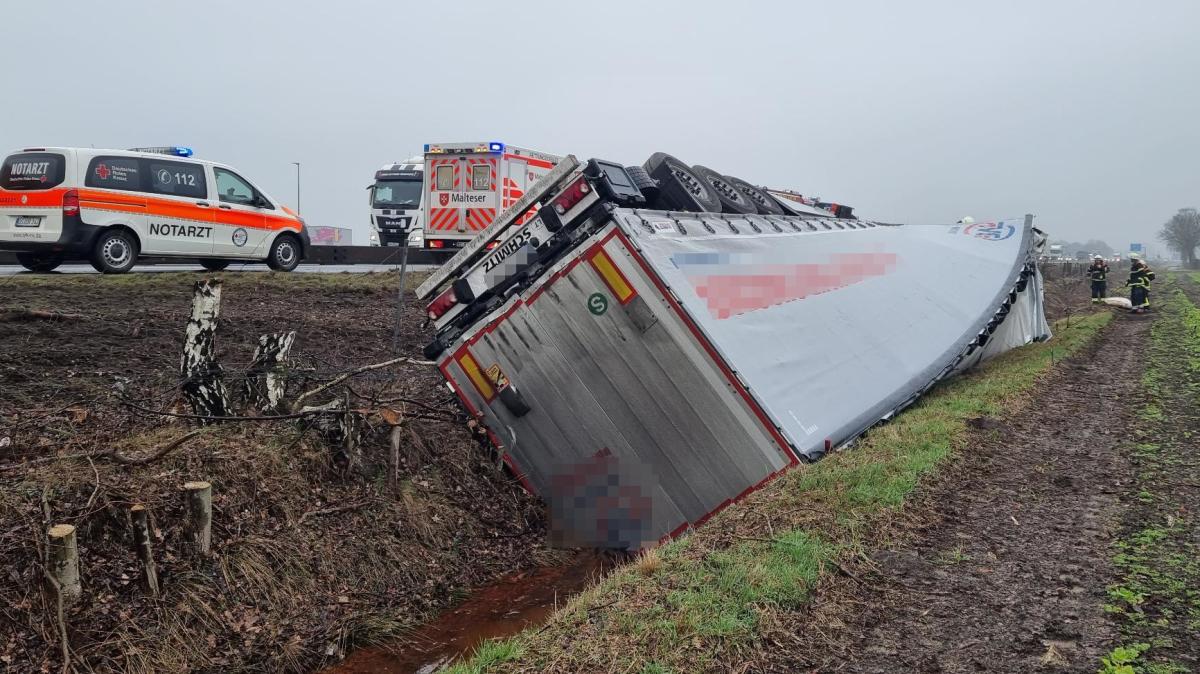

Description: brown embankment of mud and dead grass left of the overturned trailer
[0,272,562,672]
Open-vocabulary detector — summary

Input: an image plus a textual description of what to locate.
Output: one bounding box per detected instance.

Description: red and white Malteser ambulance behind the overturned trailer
[424,140,562,253]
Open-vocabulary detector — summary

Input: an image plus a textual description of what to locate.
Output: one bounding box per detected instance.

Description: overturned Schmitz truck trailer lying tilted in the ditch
[418,155,1049,547]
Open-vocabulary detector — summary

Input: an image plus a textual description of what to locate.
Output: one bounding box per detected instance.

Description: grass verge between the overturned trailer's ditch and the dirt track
[450,312,1112,674]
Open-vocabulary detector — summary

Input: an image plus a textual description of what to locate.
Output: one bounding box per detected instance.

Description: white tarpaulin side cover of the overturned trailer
[623,213,1050,458]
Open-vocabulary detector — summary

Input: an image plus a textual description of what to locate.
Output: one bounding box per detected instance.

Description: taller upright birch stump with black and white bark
[179,279,230,416]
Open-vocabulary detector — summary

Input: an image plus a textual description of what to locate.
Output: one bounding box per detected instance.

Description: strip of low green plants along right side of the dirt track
[1099,275,1200,674]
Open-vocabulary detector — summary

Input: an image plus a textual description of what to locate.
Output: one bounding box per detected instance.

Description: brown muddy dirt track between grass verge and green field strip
[790,315,1152,673]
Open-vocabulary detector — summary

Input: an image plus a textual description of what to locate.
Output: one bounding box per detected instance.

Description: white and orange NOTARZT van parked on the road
[0,148,310,273]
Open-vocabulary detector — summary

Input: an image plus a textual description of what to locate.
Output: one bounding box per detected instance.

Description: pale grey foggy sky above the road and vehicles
[0,0,1200,249]
